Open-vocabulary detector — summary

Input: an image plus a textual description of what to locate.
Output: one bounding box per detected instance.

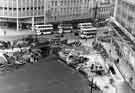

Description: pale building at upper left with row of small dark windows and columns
[0,0,45,28]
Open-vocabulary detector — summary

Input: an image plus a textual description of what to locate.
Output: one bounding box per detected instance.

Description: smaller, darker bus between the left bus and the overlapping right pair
[58,24,73,33]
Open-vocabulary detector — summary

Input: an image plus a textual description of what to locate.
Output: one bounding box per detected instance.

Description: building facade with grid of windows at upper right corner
[115,0,135,36]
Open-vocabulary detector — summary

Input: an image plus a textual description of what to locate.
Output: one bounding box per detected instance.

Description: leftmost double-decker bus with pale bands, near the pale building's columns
[34,24,53,35]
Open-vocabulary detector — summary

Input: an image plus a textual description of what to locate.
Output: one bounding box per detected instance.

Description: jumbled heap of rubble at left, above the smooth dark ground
[0,37,42,71]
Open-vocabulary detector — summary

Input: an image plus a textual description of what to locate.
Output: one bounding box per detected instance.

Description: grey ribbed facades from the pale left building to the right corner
[46,0,113,22]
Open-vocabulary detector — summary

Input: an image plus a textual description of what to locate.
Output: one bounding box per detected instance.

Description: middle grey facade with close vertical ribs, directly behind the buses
[46,0,96,22]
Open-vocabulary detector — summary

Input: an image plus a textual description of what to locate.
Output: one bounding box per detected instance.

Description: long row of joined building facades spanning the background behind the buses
[0,0,112,30]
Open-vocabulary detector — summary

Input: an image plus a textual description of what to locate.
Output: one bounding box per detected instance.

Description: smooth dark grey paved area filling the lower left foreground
[0,57,92,93]
